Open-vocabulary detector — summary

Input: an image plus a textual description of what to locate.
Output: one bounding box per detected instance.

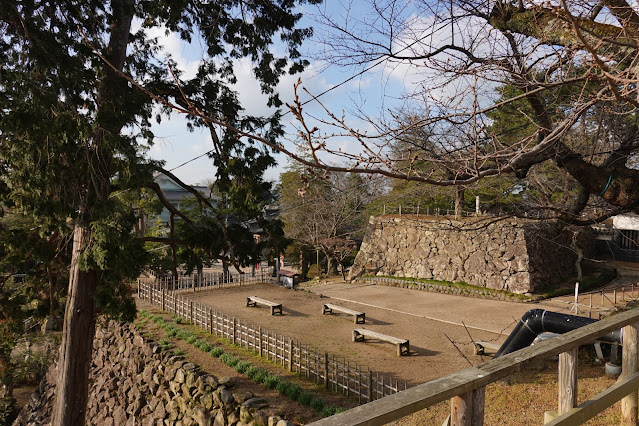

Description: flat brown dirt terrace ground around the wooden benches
[171,283,564,387]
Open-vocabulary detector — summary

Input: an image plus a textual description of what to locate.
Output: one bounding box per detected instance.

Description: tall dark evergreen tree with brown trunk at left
[0,0,316,425]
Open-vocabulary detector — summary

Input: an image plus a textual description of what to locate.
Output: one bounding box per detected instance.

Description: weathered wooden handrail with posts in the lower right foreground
[313,308,639,426]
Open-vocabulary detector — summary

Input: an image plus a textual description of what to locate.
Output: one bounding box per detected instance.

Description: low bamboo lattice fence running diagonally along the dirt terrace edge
[138,280,407,403]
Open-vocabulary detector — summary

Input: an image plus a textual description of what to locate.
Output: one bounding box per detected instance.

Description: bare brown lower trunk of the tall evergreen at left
[51,221,97,426]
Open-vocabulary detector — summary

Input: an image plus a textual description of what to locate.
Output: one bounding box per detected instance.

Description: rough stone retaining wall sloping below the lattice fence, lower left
[14,322,291,426]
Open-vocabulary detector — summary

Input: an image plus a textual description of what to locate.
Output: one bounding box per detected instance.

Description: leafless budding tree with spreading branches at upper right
[282,0,639,223]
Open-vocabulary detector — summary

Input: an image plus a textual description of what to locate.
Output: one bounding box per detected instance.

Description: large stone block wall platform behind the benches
[350,217,576,293]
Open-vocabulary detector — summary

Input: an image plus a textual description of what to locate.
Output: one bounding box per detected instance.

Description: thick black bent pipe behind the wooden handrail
[495,309,622,358]
